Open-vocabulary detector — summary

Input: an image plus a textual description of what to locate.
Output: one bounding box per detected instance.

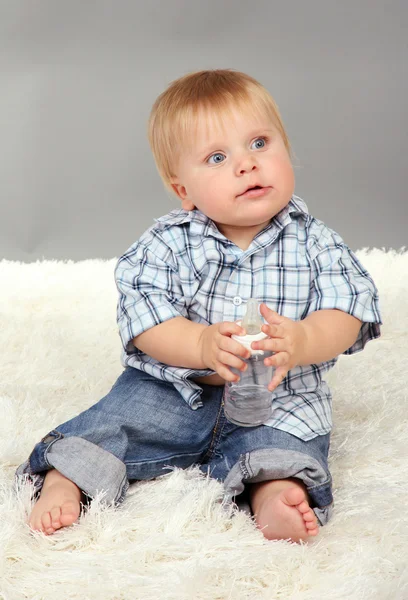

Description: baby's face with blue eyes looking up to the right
[173,106,295,248]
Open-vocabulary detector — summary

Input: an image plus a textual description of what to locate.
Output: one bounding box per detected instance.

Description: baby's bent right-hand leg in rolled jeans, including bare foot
[202,413,333,542]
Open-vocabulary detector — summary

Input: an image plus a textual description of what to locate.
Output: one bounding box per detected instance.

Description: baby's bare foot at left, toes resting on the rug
[28,469,82,535]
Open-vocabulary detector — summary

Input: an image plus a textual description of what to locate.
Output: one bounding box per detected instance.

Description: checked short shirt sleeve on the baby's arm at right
[302,222,382,354]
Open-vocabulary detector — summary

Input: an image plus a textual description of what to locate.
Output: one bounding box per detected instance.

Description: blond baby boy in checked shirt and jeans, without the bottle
[17,69,381,542]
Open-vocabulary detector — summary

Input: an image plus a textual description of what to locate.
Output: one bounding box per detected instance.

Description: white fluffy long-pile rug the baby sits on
[0,248,408,600]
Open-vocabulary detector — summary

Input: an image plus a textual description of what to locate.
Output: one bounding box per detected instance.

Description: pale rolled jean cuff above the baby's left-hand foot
[16,431,129,504]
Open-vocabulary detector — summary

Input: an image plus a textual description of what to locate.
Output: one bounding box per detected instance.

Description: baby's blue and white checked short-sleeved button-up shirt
[115,196,382,440]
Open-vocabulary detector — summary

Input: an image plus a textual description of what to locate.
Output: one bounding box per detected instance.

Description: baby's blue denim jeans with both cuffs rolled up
[16,367,333,525]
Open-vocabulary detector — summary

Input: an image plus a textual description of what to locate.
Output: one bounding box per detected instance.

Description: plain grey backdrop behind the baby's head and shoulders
[0,0,408,262]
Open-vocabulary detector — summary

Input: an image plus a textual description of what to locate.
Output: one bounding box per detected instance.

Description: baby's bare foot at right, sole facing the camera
[251,479,319,542]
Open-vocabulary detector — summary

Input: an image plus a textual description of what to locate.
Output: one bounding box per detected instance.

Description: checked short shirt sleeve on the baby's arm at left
[115,238,187,354]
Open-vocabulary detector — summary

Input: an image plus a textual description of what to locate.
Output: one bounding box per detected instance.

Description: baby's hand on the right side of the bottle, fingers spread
[251,303,306,392]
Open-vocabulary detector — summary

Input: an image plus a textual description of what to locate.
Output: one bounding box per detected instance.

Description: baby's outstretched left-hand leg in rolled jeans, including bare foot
[16,367,223,531]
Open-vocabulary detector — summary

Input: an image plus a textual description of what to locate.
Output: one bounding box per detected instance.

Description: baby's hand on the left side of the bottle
[199,321,251,381]
